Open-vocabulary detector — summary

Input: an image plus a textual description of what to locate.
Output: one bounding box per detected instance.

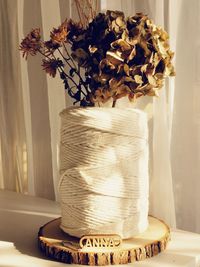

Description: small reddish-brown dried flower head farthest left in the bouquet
[19,28,42,59]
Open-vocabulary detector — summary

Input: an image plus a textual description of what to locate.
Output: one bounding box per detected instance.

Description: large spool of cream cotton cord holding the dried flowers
[59,107,149,238]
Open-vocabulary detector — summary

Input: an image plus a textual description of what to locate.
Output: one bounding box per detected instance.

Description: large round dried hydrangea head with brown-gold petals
[69,11,175,102]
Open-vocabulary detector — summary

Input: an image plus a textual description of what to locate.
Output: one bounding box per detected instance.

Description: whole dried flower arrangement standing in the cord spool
[20,11,175,107]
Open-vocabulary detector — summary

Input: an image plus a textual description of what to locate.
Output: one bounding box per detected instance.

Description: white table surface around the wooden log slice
[0,191,200,267]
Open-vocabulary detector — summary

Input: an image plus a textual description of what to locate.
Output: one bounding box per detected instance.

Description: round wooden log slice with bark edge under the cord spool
[38,216,170,265]
